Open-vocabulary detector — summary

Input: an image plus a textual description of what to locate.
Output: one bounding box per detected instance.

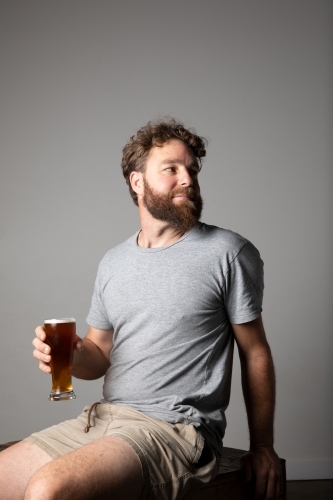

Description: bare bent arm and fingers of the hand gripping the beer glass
[32,326,113,380]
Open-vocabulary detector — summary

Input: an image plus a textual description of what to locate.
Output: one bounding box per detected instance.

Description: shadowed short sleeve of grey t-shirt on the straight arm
[224,242,264,324]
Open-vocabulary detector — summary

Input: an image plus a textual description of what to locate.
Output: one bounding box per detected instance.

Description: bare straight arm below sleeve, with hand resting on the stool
[232,317,282,500]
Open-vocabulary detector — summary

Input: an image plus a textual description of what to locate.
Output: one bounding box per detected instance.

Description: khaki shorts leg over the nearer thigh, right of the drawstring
[102,405,220,500]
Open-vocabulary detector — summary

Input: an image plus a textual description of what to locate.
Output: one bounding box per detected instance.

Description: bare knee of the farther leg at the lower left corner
[0,441,52,500]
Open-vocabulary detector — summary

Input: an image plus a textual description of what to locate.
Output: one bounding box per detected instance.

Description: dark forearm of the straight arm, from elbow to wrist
[240,344,275,448]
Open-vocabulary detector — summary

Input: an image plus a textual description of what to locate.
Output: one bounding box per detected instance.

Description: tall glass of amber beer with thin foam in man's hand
[44,318,76,401]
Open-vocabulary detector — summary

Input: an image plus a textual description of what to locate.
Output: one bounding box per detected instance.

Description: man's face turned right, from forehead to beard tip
[142,139,202,233]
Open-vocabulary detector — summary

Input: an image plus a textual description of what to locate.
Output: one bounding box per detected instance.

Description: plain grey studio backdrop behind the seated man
[0,0,333,479]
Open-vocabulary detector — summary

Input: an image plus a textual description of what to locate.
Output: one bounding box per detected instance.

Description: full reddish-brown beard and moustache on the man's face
[142,177,203,233]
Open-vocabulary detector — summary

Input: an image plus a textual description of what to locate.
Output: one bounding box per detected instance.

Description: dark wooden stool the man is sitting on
[0,441,287,500]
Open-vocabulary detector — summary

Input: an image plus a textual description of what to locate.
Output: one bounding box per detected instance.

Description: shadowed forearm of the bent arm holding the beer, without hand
[72,338,110,380]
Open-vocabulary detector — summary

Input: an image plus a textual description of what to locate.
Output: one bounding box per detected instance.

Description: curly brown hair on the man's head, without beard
[121,117,208,205]
